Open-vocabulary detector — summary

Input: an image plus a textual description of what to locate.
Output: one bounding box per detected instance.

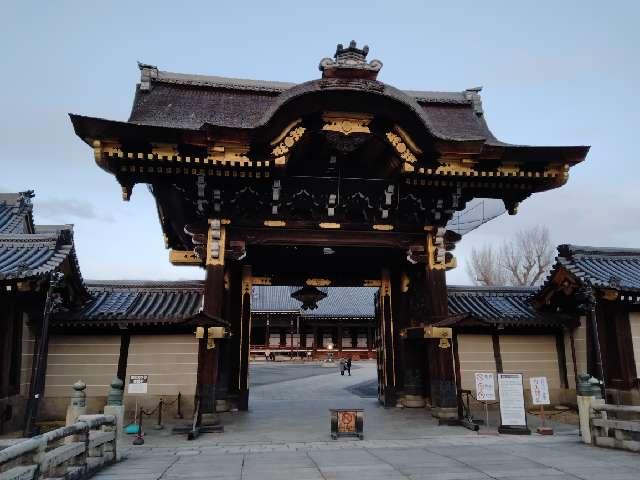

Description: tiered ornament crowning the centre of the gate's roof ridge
[318,40,382,80]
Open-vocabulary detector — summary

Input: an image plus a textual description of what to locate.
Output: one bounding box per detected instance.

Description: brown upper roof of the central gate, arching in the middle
[129,68,493,141]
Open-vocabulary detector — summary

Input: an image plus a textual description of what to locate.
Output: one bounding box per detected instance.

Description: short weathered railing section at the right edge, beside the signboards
[590,404,640,452]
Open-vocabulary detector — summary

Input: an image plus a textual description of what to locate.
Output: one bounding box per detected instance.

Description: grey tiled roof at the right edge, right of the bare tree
[548,245,640,292]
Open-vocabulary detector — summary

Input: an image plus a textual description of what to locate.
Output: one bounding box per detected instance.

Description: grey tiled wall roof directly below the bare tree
[447,286,566,327]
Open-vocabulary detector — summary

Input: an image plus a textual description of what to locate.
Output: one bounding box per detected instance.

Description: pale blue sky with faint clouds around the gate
[0,0,640,283]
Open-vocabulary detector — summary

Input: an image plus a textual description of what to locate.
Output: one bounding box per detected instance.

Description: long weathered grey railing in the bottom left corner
[0,415,117,480]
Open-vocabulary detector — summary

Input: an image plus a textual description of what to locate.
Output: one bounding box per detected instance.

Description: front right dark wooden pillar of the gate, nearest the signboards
[425,264,458,420]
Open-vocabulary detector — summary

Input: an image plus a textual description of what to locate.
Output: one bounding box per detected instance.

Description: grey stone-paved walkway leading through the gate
[96,364,640,480]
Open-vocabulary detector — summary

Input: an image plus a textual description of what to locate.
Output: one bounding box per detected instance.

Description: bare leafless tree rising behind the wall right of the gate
[467,225,555,286]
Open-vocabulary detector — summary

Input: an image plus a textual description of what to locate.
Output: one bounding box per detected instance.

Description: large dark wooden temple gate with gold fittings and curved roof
[71,42,587,430]
